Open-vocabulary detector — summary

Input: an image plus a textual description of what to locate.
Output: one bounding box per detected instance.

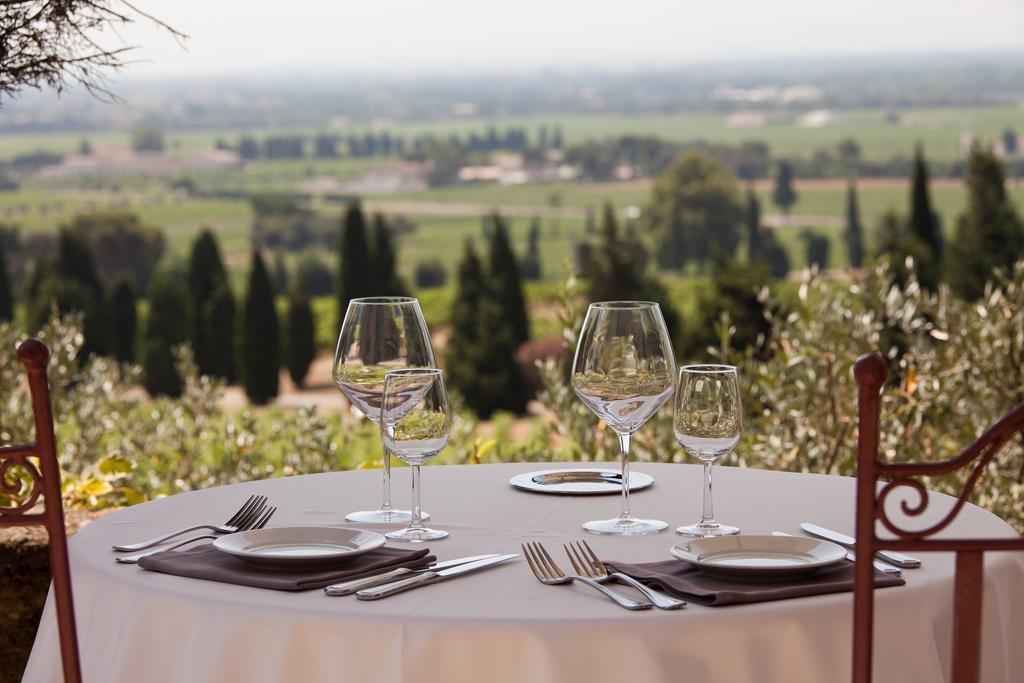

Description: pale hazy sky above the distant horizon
[110,0,1024,76]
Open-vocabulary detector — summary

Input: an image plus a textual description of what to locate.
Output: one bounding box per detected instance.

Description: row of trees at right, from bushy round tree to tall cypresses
[644,140,1024,298]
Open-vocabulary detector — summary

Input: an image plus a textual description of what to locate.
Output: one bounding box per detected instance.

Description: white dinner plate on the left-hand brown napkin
[213,526,387,569]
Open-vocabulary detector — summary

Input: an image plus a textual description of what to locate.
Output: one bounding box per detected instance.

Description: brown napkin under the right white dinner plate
[605,560,906,607]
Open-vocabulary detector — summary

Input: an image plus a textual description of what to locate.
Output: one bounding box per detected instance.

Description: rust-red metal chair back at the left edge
[0,339,82,683]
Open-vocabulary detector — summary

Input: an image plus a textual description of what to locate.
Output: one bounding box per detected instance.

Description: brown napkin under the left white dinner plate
[138,545,437,591]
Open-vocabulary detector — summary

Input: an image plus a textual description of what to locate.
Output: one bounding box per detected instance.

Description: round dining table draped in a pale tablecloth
[24,463,1024,683]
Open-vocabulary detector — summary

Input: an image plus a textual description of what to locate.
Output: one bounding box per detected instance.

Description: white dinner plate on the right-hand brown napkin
[672,535,846,579]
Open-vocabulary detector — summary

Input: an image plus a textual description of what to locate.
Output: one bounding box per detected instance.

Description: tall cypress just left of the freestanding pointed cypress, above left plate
[188,228,234,379]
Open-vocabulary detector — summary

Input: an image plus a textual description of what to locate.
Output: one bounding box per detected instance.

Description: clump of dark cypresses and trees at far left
[0,216,315,403]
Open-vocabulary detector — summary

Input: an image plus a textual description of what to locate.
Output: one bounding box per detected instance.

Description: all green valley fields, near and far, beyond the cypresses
[0,106,1024,288]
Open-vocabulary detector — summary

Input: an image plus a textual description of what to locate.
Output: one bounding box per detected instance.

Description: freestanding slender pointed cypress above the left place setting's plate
[242,249,281,405]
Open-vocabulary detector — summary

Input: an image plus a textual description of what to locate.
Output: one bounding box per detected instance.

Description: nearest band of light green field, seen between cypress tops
[0,180,1024,284]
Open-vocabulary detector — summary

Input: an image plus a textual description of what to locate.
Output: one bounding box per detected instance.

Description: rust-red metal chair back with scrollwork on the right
[853,354,1024,683]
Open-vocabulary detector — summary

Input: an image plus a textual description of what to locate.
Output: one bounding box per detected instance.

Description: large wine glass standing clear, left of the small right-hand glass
[572,301,676,536]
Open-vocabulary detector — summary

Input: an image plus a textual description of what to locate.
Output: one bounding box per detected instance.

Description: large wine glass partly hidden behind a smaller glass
[334,297,434,523]
